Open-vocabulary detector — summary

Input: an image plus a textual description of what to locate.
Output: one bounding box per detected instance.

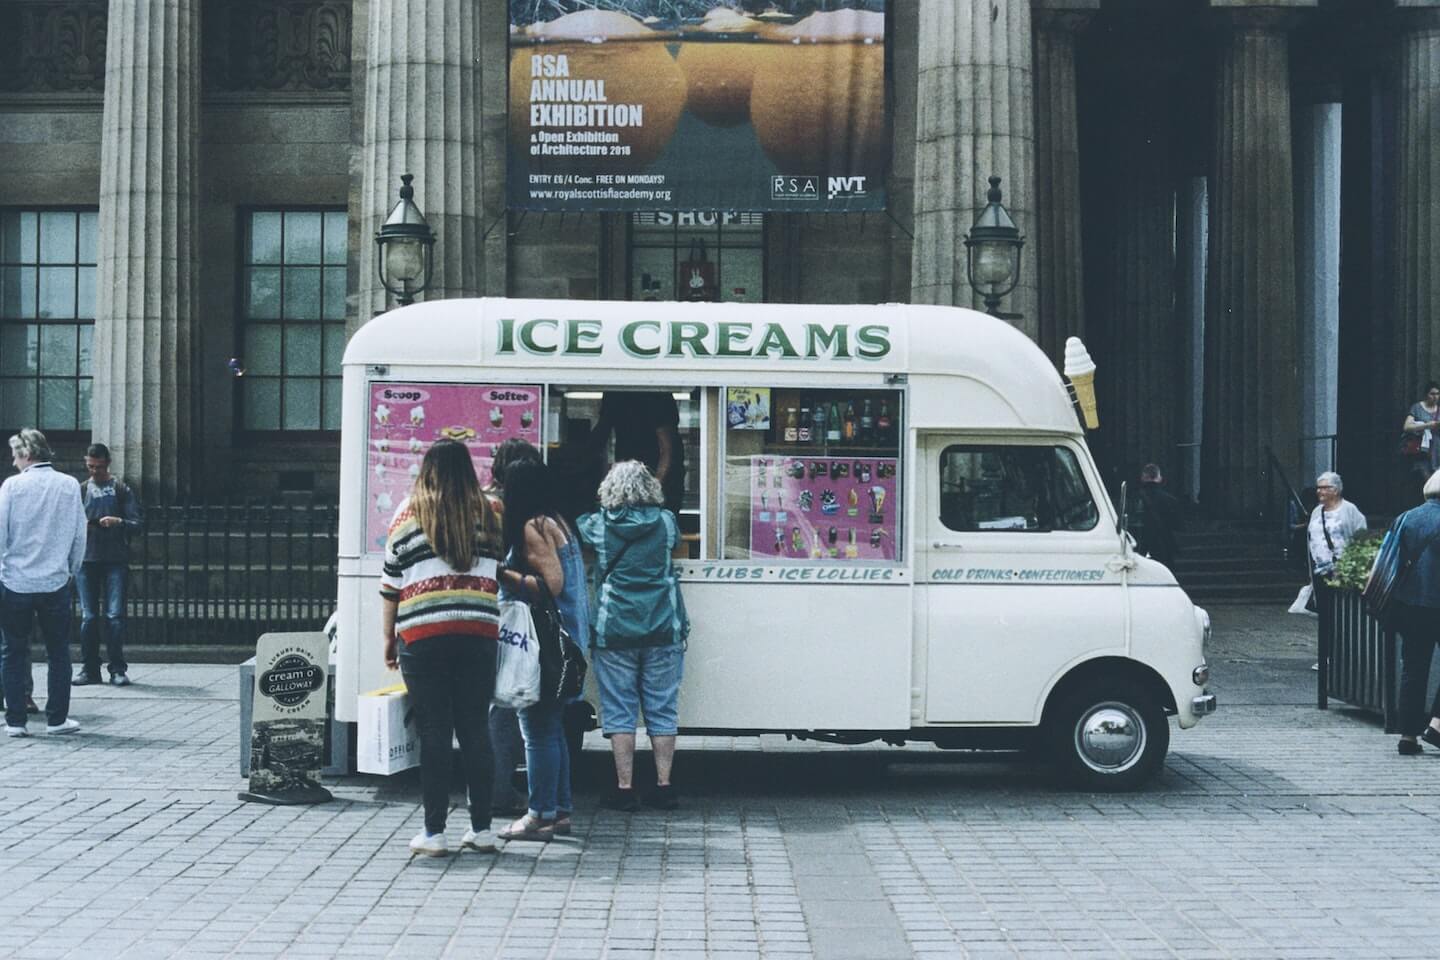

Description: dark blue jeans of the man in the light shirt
[0,584,71,727]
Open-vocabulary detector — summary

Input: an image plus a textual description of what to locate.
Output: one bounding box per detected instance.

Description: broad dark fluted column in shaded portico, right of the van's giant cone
[1202,0,1313,517]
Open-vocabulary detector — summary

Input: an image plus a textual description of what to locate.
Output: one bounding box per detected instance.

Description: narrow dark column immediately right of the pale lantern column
[1031,0,1100,361]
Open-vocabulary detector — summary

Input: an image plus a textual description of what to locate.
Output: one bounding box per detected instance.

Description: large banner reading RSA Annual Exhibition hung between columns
[507,0,890,213]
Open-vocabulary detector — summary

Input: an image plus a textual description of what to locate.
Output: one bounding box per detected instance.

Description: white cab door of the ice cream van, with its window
[916,435,1128,724]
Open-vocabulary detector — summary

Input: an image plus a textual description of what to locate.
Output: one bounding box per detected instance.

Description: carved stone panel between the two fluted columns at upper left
[200,0,351,92]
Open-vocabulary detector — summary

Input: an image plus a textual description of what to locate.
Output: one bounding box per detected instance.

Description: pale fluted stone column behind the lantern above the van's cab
[910,0,1038,337]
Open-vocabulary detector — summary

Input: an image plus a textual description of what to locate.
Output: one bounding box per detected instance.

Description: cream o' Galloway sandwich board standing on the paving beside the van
[239,630,333,805]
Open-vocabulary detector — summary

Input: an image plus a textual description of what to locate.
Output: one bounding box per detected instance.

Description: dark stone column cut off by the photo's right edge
[1391,0,1440,423]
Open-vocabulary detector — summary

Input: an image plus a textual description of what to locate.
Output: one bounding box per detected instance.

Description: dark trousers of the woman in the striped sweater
[400,635,495,833]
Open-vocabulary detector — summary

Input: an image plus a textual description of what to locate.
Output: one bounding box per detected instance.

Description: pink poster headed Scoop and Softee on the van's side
[364,383,540,553]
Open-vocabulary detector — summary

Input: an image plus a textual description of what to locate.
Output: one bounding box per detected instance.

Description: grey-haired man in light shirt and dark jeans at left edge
[0,427,85,737]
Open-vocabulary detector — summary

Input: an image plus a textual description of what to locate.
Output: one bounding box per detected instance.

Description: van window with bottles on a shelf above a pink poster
[721,387,903,563]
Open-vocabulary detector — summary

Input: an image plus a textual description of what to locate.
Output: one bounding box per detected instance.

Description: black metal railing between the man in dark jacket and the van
[99,497,338,646]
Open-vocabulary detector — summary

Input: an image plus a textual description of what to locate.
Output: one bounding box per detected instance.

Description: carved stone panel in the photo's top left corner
[0,0,107,94]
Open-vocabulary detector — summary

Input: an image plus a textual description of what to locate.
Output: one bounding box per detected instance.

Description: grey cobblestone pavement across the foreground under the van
[0,607,1440,960]
